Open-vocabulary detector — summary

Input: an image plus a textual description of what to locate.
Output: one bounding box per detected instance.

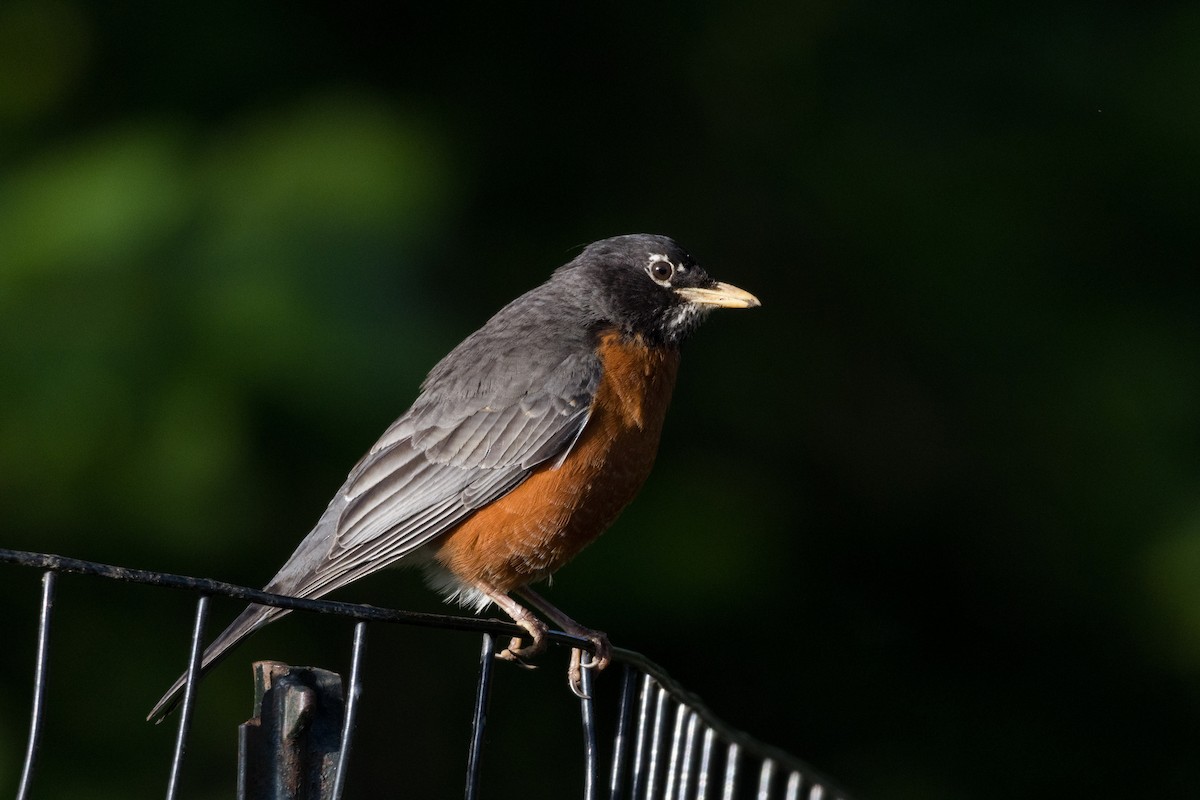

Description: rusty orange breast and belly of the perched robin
[433,333,679,593]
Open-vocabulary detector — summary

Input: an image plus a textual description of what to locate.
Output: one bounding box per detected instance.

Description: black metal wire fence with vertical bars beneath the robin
[0,549,847,800]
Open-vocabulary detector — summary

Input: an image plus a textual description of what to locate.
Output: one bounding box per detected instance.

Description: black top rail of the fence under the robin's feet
[0,548,845,796]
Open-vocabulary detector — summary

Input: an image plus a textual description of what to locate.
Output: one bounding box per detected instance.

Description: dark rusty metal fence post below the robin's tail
[238,661,346,800]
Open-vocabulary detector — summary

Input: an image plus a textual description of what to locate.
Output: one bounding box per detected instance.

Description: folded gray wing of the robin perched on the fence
[268,350,601,596]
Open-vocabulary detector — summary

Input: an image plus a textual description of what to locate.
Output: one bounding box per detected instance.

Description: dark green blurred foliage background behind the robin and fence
[0,0,1200,800]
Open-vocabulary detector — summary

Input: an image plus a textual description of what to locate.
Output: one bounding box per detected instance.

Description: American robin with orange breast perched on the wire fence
[149,235,760,720]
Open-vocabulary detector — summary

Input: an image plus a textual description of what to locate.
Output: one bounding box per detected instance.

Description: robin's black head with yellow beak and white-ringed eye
[556,234,761,344]
